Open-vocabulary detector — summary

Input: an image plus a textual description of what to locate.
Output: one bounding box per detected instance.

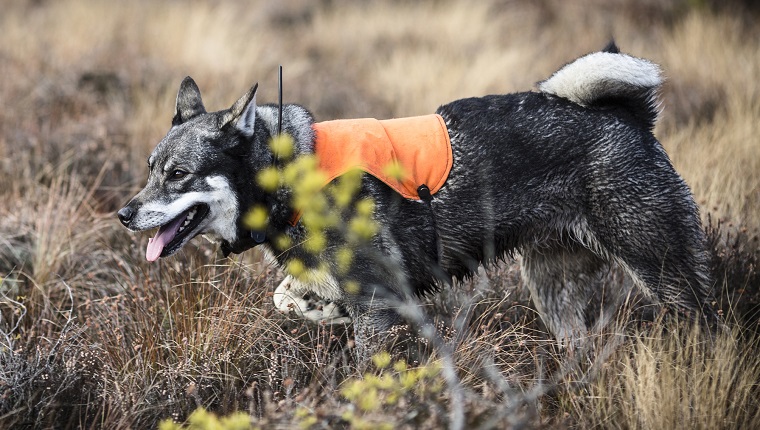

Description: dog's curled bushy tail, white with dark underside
[538,42,662,129]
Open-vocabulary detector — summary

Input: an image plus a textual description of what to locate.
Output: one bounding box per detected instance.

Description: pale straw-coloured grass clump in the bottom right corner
[571,324,760,429]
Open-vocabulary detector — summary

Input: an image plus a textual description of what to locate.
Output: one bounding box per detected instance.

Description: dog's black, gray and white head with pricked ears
[118,77,269,261]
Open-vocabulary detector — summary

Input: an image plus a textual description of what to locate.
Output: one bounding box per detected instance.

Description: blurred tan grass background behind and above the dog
[0,0,760,227]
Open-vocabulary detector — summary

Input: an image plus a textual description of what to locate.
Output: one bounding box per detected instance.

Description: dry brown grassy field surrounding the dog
[0,0,760,429]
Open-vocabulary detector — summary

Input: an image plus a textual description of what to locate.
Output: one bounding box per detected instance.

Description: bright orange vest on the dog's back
[291,114,453,225]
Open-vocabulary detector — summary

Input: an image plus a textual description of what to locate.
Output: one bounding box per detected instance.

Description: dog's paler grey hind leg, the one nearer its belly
[521,237,619,349]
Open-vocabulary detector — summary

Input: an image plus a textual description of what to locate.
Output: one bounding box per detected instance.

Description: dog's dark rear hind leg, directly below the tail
[590,186,722,330]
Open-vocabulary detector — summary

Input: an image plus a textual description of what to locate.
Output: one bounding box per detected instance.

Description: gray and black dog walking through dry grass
[118,44,719,352]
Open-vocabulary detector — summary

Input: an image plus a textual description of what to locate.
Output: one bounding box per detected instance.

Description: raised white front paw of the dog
[273,276,351,324]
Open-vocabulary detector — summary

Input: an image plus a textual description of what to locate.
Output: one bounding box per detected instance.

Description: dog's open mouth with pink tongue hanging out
[145,204,209,261]
